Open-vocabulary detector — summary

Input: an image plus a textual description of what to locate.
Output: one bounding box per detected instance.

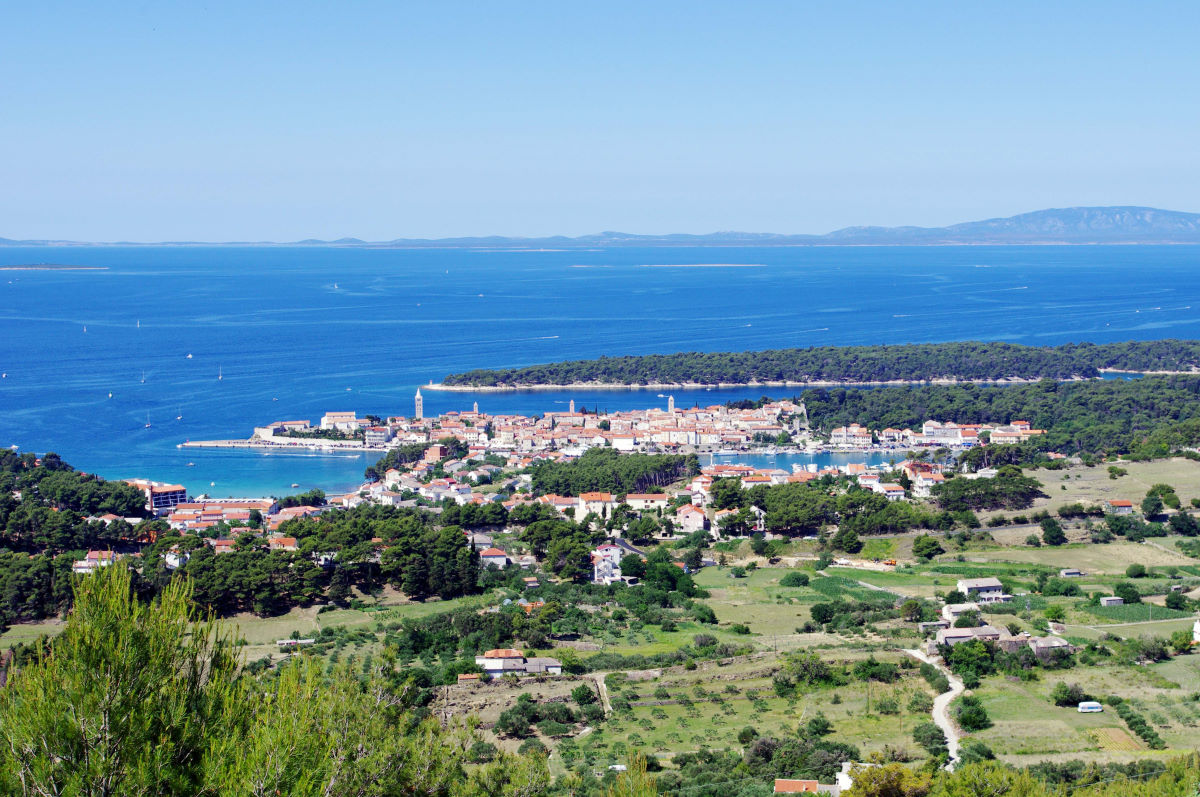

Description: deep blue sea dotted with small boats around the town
[0,246,1200,496]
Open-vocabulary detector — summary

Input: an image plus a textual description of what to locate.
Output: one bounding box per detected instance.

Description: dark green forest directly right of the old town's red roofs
[800,376,1200,456]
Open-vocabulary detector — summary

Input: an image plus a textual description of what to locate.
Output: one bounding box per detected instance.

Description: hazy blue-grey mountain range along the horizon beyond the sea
[0,206,1200,250]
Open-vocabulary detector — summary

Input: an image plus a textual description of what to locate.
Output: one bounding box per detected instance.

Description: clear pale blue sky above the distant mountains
[0,0,1200,241]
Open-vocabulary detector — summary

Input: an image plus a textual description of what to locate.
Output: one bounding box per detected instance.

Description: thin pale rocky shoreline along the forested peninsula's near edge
[421,368,1200,392]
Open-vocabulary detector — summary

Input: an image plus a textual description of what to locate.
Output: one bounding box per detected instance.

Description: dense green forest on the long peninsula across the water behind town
[443,340,1200,386]
